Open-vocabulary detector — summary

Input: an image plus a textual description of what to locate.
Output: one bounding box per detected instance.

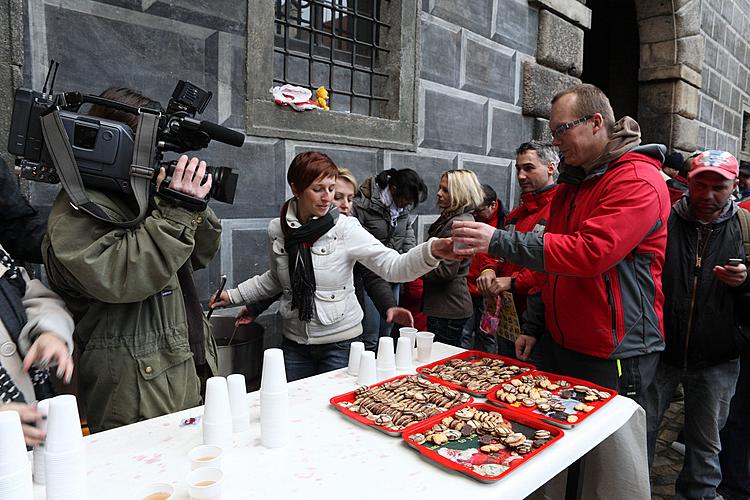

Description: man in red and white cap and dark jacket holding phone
[646,151,750,498]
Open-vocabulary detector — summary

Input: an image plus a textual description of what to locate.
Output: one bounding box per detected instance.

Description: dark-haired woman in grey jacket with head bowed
[354,168,427,350]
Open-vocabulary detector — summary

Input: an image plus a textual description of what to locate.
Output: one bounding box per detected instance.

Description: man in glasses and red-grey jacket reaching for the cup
[453,84,670,406]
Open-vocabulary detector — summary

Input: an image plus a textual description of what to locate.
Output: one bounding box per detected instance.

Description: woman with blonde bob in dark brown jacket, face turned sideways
[422,169,484,346]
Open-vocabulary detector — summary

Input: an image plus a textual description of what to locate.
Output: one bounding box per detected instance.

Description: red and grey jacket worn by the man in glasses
[490,145,670,359]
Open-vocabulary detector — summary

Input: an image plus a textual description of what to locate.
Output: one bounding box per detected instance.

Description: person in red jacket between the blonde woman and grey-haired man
[461,184,505,353]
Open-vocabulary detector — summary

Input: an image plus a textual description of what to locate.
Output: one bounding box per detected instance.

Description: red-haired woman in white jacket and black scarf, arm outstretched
[213,152,454,380]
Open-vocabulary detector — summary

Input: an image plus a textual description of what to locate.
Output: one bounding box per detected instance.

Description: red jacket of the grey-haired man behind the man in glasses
[496,185,557,317]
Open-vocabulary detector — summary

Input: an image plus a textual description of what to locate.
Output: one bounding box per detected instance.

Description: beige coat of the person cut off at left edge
[0,263,73,403]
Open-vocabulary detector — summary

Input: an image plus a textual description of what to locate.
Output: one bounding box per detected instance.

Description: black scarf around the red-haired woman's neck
[281,201,339,323]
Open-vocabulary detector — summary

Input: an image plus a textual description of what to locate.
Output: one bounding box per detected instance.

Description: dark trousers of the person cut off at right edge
[719,352,750,500]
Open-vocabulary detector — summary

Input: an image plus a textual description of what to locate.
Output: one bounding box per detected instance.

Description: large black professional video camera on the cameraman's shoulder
[8,80,244,203]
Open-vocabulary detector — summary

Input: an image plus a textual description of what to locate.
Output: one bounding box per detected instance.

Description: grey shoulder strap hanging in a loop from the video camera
[41,108,160,228]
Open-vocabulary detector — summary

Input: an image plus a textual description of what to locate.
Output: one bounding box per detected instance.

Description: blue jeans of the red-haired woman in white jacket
[281,335,362,382]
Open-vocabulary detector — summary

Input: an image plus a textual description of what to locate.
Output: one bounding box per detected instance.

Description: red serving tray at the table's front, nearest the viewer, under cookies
[402,403,564,483]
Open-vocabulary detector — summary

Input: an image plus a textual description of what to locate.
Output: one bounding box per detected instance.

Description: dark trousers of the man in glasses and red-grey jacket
[541,335,660,413]
